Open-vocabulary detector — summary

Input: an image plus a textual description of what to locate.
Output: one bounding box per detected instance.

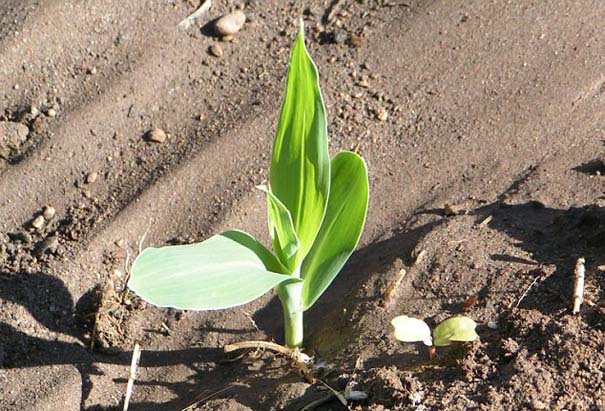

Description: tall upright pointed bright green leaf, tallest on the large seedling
[270,23,330,258]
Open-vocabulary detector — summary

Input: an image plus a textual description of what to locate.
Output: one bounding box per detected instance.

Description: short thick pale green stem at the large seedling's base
[277,282,303,348]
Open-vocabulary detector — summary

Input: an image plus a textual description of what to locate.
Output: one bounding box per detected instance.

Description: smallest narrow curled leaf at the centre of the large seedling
[257,186,300,272]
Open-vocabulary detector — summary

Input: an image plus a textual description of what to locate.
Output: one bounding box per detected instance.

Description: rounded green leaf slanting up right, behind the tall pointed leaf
[301,151,369,310]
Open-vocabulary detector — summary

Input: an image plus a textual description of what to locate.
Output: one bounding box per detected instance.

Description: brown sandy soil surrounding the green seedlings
[0,0,605,411]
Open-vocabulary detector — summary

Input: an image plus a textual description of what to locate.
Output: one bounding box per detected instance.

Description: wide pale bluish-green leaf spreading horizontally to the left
[128,231,292,310]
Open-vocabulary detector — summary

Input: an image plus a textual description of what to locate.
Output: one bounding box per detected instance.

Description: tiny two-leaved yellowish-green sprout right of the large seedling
[391,315,479,347]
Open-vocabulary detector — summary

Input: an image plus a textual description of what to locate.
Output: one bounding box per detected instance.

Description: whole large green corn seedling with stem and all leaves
[128,23,369,347]
